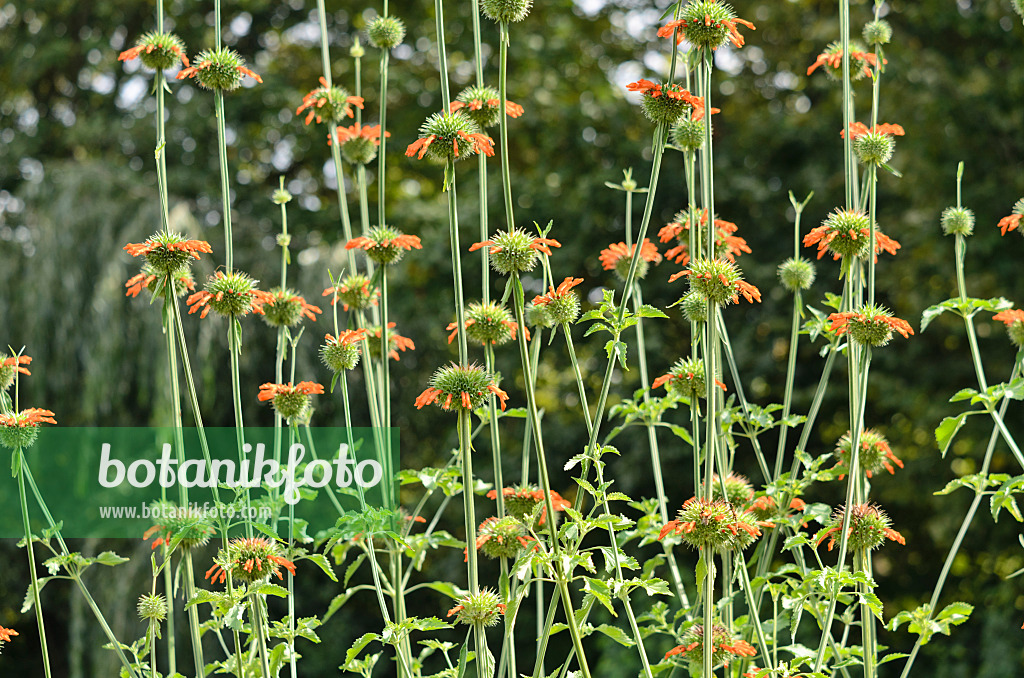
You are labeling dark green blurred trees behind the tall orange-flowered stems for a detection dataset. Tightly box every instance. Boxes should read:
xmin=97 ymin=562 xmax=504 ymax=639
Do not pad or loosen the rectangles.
xmin=0 ymin=0 xmax=1024 ymax=678
